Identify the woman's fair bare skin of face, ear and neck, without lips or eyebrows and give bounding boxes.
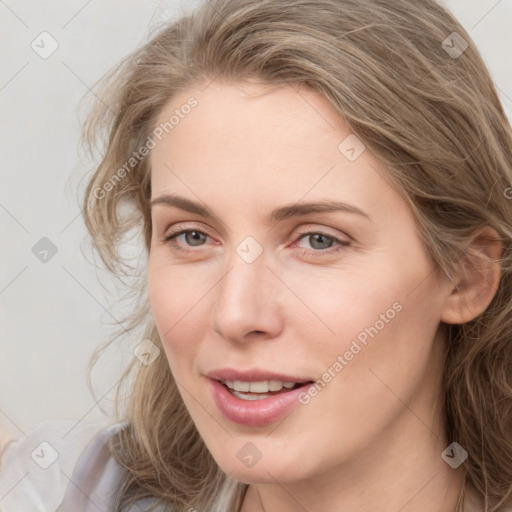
[147,81,499,512]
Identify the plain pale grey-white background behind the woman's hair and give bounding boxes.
[0,0,512,444]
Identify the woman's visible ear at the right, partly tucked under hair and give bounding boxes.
[441,226,502,324]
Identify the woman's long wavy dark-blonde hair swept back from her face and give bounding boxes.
[83,0,512,512]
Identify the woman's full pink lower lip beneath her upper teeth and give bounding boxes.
[209,379,313,427]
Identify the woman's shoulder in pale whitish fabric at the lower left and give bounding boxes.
[0,419,124,512]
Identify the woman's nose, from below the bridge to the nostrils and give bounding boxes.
[211,252,283,343]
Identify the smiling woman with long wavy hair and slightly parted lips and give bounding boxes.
[1,0,512,512]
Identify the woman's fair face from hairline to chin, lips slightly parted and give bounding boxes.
[148,82,448,482]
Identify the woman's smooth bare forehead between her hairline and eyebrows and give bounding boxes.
[146,82,402,221]
